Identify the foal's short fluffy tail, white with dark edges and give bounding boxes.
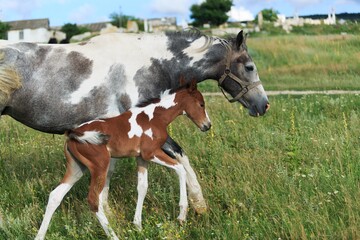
[66,130,110,145]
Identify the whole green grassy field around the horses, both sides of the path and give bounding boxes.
[0,36,360,240]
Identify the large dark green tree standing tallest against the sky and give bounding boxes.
[190,0,233,27]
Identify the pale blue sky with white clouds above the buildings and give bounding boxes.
[0,0,360,26]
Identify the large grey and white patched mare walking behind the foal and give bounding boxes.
[0,29,270,218]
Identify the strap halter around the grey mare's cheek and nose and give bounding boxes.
[218,58,261,103]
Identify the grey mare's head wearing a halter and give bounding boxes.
[219,31,270,116]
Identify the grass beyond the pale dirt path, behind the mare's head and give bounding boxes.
[198,35,360,91]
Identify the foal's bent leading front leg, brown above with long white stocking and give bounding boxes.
[151,150,188,223]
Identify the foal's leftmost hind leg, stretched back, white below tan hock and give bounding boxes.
[35,144,86,240]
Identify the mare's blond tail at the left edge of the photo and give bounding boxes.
[0,51,21,108]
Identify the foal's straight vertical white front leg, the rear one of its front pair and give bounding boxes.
[134,157,149,230]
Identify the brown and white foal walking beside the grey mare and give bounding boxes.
[36,82,211,239]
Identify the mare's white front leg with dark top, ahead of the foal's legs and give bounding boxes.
[162,137,207,214]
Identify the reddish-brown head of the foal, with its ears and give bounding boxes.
[176,81,211,132]
